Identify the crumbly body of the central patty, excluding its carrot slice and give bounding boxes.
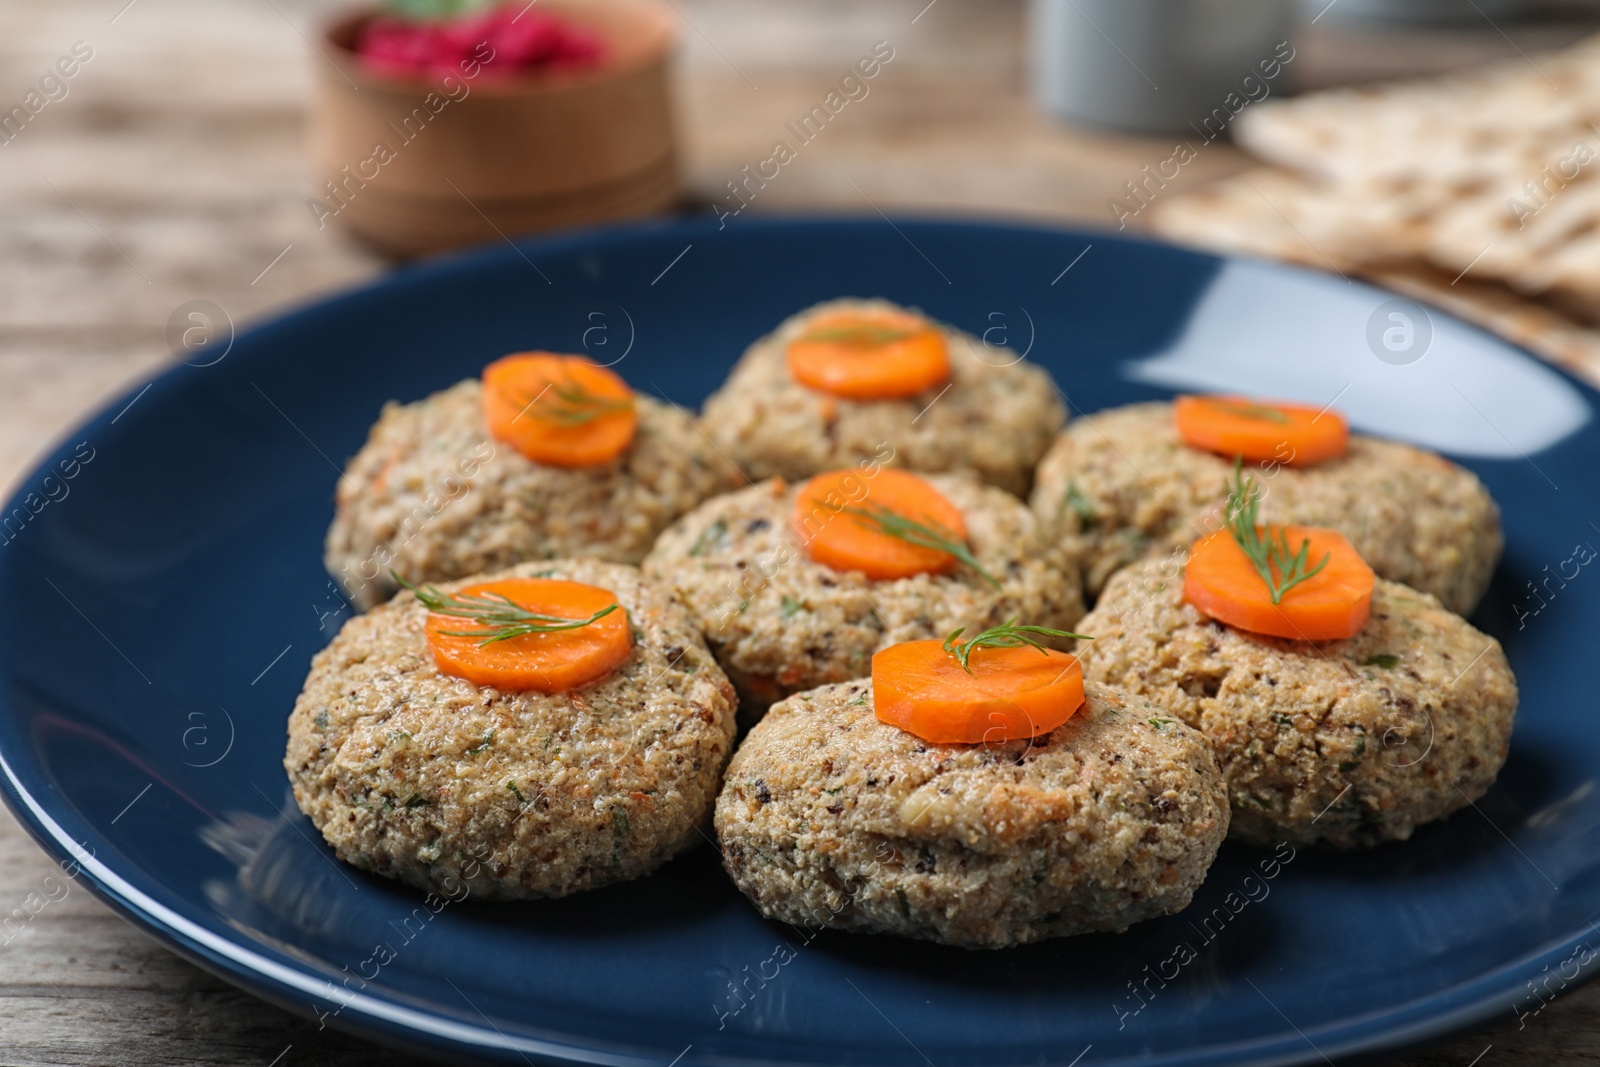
[643,467,1083,717]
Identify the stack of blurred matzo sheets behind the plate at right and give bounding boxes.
[1154,37,1600,381]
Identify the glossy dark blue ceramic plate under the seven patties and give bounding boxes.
[0,219,1600,1067]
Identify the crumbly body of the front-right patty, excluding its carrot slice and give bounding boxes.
[1078,560,1517,848]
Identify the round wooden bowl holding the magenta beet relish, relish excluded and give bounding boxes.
[309,0,680,256]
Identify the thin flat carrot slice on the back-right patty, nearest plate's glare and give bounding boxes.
[1173,397,1350,467]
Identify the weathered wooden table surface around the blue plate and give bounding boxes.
[0,0,1600,1067]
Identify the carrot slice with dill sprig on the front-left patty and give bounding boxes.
[418,577,634,693]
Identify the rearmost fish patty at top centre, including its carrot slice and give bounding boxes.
[702,299,1067,494]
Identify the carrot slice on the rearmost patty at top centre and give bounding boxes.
[787,310,950,400]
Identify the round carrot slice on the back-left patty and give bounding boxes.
[483,352,638,467]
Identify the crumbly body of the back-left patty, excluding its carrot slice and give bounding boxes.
[326,379,744,608]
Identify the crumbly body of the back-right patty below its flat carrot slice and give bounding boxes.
[1032,403,1502,614]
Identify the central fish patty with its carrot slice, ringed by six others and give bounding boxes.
[643,464,1083,720]
